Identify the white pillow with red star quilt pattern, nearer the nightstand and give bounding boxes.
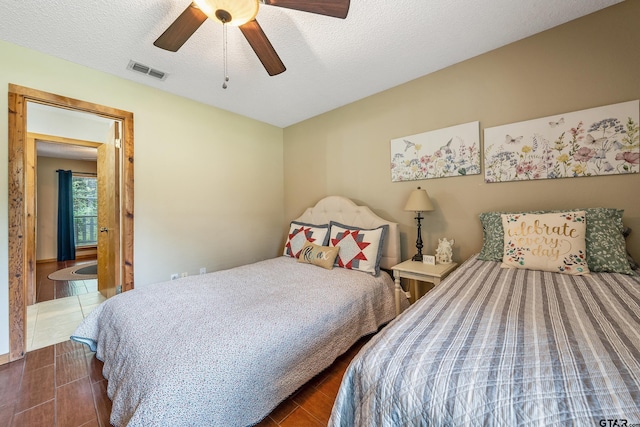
[329,221,389,276]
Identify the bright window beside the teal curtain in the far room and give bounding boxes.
[73,174,98,247]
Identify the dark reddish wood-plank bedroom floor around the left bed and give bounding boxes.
[0,337,370,427]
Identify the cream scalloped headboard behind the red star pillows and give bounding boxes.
[296,196,401,269]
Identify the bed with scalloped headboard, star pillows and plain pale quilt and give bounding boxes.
[72,196,408,426]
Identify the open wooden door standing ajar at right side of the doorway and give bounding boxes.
[97,122,121,298]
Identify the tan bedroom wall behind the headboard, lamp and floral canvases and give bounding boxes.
[284,1,640,260]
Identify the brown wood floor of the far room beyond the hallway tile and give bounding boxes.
[36,258,98,302]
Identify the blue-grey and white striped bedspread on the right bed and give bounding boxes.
[329,257,640,426]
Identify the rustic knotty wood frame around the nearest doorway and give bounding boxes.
[8,83,133,361]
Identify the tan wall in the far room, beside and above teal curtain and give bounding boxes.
[36,157,97,260]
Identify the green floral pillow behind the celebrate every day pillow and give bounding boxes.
[478,208,635,275]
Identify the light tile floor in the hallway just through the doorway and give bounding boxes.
[27,292,105,352]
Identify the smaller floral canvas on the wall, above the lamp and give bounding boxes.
[391,122,480,182]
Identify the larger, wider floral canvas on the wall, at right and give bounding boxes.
[484,100,640,182]
